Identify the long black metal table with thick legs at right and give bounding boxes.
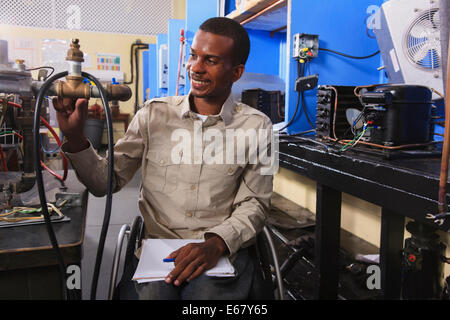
[279,138,450,299]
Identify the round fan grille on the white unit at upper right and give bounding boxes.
[403,8,441,71]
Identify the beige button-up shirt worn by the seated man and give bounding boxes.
[63,95,273,255]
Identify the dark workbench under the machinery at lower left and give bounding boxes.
[0,171,88,299]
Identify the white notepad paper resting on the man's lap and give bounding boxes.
[133,239,234,283]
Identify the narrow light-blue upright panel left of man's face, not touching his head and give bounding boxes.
[167,19,186,96]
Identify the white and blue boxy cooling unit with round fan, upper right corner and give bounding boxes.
[374,0,444,99]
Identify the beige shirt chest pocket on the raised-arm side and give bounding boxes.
[145,149,180,193]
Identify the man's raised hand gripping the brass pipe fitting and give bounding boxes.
[52,97,89,153]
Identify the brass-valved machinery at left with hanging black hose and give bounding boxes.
[0,39,131,298]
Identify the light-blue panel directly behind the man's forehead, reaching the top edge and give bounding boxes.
[184,0,218,93]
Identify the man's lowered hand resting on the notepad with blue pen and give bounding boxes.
[165,234,228,286]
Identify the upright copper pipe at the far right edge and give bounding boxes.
[438,33,450,213]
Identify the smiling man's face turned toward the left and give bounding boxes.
[186,30,244,99]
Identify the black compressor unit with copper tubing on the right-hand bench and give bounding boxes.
[316,84,438,157]
